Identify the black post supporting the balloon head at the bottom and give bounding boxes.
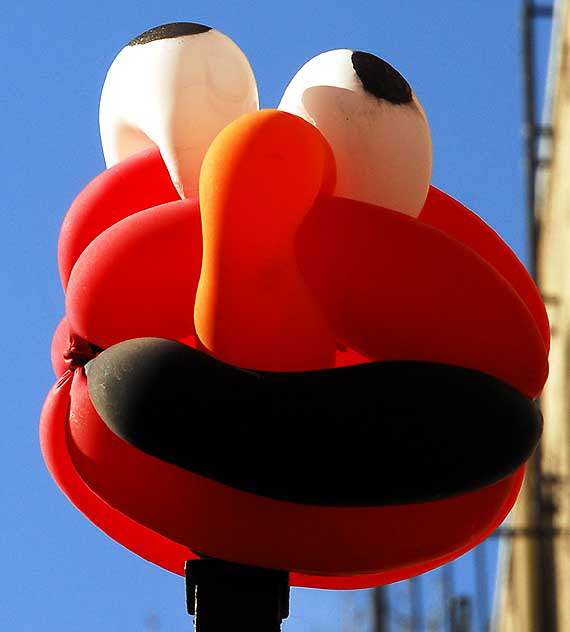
[186,558,289,632]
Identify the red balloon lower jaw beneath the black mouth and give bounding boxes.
[40,370,522,589]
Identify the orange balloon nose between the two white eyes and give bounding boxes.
[194,110,335,371]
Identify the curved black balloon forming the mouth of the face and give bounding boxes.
[85,338,542,507]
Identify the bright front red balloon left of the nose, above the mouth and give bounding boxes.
[66,200,202,348]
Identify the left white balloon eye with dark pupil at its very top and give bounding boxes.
[99,22,258,197]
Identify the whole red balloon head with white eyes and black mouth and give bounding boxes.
[41,23,549,628]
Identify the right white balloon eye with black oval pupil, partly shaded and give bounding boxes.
[279,49,432,217]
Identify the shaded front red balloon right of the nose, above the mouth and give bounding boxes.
[297,197,548,397]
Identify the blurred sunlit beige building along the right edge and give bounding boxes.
[494,0,570,632]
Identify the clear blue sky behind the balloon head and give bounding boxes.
[0,0,544,632]
